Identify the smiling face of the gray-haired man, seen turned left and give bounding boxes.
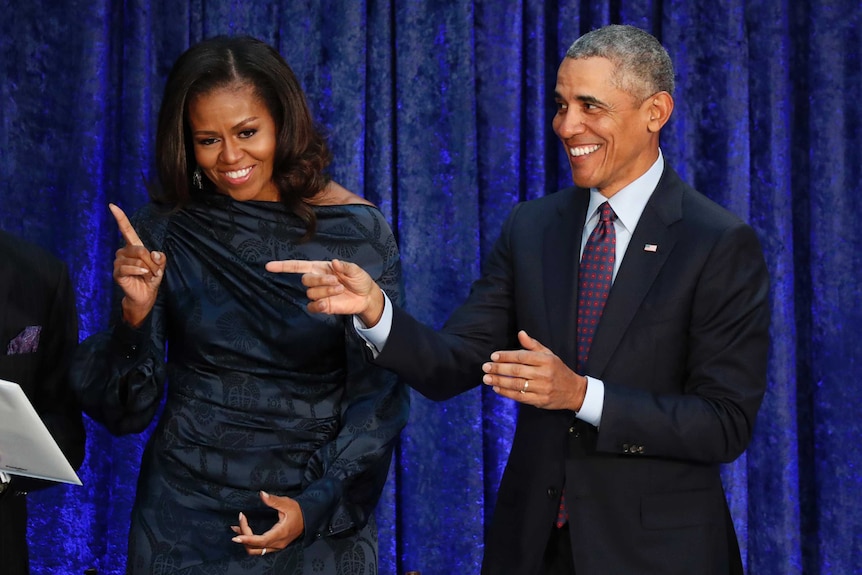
[553,58,658,198]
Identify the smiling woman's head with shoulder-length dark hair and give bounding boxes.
[152,36,342,240]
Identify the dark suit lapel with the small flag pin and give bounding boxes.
[587,167,683,378]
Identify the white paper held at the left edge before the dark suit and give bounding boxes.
[0,379,81,485]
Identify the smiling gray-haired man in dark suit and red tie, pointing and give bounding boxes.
[268,26,769,575]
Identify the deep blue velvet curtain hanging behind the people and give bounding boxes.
[0,0,862,575]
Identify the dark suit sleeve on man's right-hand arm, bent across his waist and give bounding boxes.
[597,223,769,463]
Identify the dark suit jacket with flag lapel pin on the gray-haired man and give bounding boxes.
[376,167,769,575]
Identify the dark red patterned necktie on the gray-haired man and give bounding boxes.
[557,202,617,527]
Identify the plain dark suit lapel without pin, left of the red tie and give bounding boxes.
[542,190,590,368]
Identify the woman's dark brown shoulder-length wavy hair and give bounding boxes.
[151,36,331,238]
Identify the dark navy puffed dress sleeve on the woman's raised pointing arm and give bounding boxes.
[71,208,166,435]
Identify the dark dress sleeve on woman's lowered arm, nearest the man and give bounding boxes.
[296,212,410,545]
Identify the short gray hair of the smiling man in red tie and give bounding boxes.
[566,24,674,102]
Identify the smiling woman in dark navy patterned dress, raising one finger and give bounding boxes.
[73,37,409,575]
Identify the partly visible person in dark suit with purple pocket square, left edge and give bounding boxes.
[0,231,84,575]
